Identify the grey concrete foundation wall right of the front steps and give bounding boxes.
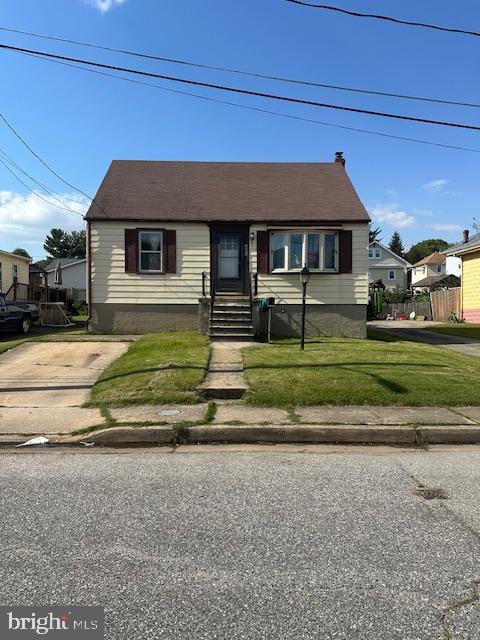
[254,304,367,338]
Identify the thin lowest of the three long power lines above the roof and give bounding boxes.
[25,49,480,153]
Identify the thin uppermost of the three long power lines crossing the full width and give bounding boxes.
[0,27,480,109]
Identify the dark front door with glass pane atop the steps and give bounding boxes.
[214,231,248,293]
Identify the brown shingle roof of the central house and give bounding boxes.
[87,160,369,222]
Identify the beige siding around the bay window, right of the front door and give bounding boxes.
[250,224,368,304]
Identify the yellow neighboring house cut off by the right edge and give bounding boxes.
[445,230,480,322]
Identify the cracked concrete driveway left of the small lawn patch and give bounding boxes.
[0,341,130,435]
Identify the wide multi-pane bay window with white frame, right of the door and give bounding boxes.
[270,231,338,271]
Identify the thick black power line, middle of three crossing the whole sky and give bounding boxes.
[0,44,480,131]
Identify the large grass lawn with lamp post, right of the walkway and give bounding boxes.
[243,332,480,407]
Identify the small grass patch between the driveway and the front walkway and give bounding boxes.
[88,331,210,407]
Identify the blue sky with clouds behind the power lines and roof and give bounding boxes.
[0,0,480,258]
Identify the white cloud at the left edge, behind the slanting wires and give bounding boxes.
[0,191,88,254]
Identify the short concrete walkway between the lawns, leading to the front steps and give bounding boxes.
[199,340,252,400]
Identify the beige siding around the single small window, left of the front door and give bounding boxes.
[91,222,210,304]
